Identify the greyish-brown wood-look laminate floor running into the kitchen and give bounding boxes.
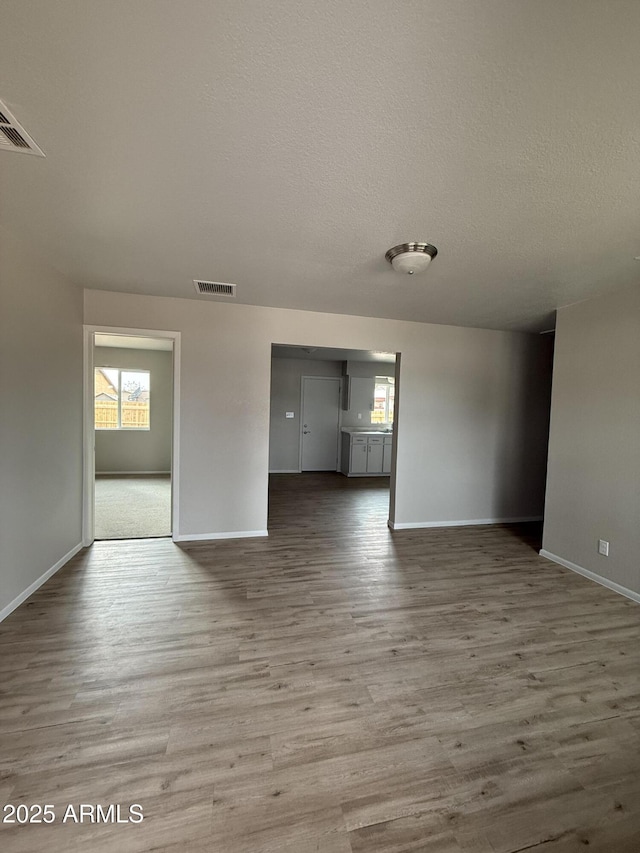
[0,474,640,853]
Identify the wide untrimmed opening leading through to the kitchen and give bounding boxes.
[269,344,399,530]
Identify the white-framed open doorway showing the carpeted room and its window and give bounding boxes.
[84,327,178,545]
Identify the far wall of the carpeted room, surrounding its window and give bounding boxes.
[94,347,173,474]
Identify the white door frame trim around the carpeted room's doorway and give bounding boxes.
[82,324,180,548]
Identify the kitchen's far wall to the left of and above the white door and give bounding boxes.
[269,358,342,472]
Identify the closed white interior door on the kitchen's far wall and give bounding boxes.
[300,376,340,471]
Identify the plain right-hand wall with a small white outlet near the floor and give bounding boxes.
[543,286,640,595]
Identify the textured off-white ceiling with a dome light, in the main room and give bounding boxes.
[0,0,640,331]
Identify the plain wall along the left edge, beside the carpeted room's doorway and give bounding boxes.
[0,228,82,618]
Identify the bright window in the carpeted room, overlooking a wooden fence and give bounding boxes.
[95,367,151,429]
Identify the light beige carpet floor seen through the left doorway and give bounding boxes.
[95,475,171,539]
